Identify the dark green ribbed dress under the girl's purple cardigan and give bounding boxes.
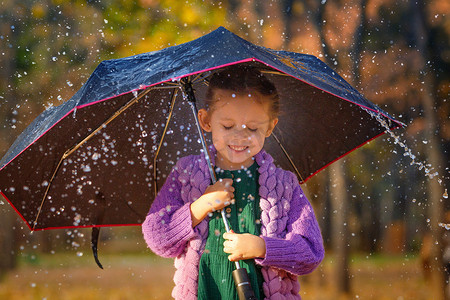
[198,163,264,300]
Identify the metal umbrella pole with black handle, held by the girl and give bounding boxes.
[181,80,256,300]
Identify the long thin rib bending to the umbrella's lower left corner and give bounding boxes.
[33,87,154,230]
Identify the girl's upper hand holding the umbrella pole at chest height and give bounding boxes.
[190,178,234,227]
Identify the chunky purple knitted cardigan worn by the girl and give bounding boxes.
[142,148,324,300]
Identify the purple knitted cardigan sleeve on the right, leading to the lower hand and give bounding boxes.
[255,175,325,275]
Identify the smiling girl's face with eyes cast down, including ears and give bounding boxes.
[198,89,278,170]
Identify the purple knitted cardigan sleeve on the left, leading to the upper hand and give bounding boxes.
[142,161,196,257]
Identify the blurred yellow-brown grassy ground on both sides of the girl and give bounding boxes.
[0,251,432,300]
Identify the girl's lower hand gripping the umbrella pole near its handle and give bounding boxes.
[223,232,266,261]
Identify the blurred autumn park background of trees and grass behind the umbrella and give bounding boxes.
[0,0,450,299]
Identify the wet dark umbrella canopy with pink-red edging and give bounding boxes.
[0,27,402,230]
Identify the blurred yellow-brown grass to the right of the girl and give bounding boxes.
[300,255,435,300]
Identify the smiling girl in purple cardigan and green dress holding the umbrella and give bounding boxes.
[142,65,324,299]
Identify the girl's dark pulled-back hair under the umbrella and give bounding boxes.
[205,64,280,119]
